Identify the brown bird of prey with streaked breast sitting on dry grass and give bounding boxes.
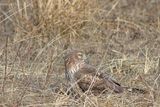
[64,50,124,93]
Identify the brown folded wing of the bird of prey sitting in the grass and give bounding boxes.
[75,64,123,93]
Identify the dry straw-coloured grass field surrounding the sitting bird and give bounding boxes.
[0,0,160,107]
